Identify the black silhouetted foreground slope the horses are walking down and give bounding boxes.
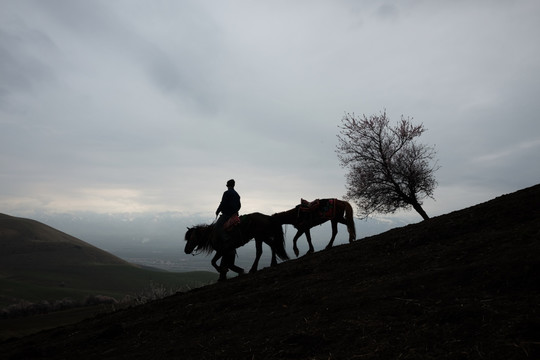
[0,185,540,360]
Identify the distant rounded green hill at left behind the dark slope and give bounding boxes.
[0,214,217,306]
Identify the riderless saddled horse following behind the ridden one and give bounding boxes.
[272,199,356,257]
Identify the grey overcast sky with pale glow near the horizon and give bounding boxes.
[0,0,540,221]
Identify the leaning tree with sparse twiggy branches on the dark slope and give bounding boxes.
[336,111,439,220]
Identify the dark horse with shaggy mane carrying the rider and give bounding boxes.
[184,212,289,280]
